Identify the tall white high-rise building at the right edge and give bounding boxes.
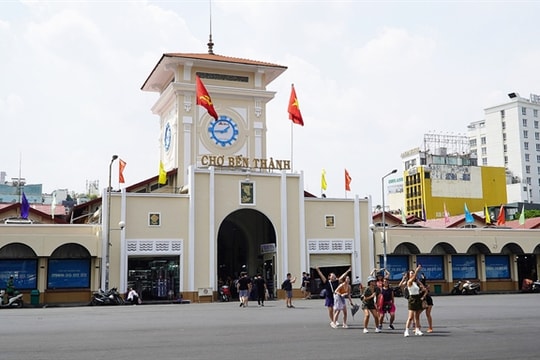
[468,93,540,203]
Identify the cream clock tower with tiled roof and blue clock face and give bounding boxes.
[142,51,287,187]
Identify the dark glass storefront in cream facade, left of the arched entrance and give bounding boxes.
[128,256,180,300]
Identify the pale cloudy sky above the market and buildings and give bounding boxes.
[0,0,540,205]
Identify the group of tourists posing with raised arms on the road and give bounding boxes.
[316,265,433,337]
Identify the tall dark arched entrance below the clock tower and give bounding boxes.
[217,209,276,296]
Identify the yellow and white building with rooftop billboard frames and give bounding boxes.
[401,134,506,219]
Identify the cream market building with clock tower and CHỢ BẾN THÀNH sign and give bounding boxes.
[0,48,540,303]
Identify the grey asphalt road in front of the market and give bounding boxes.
[0,294,540,360]
